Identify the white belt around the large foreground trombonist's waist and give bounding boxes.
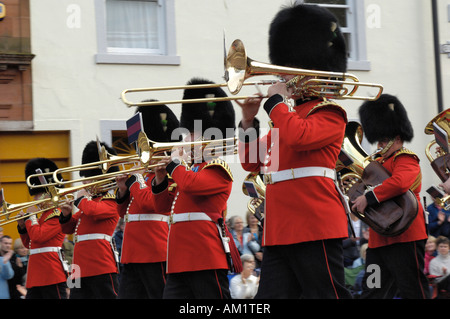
[264,166,336,184]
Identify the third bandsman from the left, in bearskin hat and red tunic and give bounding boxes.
[116,105,179,299]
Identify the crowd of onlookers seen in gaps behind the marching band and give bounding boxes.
[0,203,450,299]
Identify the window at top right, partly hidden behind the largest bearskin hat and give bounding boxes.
[297,0,370,70]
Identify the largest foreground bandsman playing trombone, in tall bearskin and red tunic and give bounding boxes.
[239,5,351,299]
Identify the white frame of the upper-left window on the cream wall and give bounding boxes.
[94,0,180,65]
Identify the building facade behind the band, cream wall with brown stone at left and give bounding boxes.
[0,0,450,235]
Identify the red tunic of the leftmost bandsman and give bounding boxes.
[20,209,67,288]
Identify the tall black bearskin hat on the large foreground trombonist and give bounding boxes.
[269,4,347,72]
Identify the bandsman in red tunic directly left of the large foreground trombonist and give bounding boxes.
[153,79,240,299]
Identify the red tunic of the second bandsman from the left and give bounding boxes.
[61,197,119,278]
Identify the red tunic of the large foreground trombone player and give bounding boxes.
[239,99,348,246]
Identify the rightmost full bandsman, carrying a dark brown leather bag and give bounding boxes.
[352,94,430,299]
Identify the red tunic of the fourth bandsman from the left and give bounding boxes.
[165,163,233,274]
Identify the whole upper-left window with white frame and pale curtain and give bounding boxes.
[95,0,180,65]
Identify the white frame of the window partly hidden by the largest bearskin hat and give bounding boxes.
[296,0,371,71]
